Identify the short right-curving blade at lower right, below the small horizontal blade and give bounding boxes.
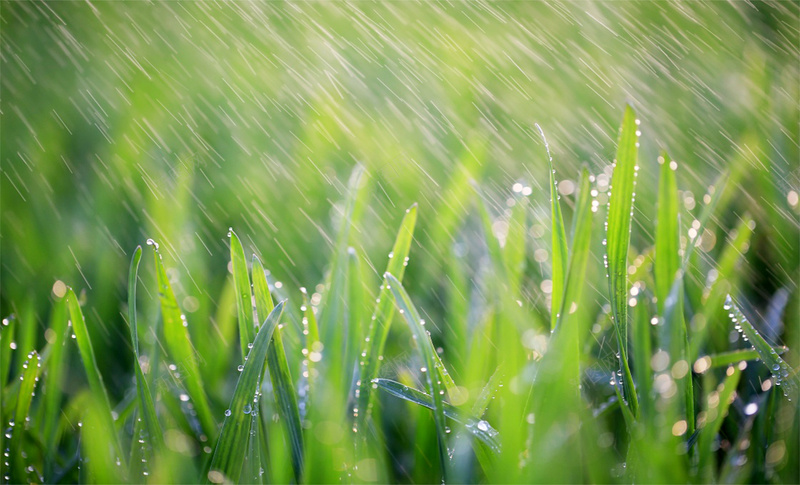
[697,365,742,483]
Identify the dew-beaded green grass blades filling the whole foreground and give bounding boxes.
[2,107,798,483]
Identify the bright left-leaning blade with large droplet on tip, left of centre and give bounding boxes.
[147,239,217,441]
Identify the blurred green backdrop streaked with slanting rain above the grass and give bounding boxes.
[0,2,800,402]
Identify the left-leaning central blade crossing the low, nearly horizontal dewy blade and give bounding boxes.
[384,273,449,482]
